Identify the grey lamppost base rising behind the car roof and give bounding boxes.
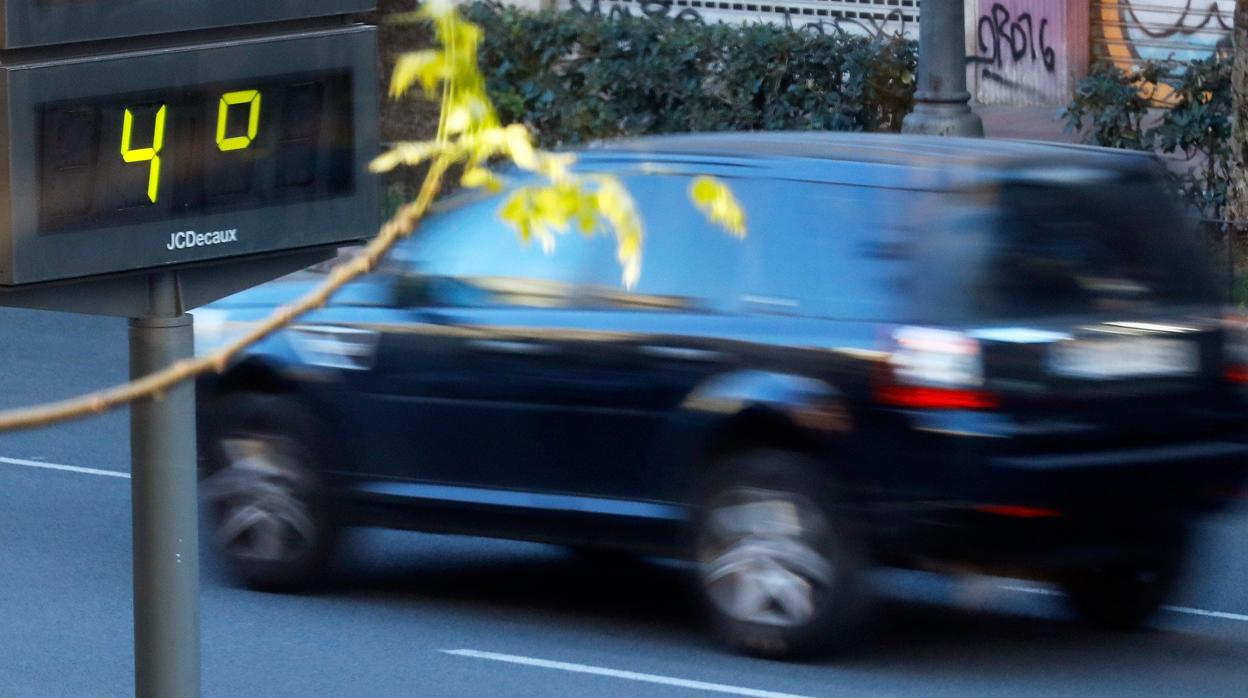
[901,0,983,137]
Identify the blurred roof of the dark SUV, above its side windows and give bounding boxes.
[578,131,1157,189]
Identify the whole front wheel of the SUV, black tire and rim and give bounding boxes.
[200,393,339,592]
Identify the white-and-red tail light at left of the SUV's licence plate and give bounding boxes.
[875,327,1000,410]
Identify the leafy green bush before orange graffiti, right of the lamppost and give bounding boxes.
[1065,54,1232,219]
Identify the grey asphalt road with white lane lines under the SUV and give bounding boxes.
[0,311,1248,698]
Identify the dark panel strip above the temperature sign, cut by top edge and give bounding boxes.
[0,0,377,49]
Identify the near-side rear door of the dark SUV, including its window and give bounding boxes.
[526,172,745,501]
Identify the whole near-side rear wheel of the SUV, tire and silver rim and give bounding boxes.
[694,450,865,659]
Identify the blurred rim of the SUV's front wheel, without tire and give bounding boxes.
[203,435,317,562]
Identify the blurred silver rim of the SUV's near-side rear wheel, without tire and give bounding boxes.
[699,488,836,627]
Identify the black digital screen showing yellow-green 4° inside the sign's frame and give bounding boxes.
[39,71,356,233]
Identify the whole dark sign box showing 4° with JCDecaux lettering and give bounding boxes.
[0,25,381,286]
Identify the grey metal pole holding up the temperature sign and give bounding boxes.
[130,272,200,698]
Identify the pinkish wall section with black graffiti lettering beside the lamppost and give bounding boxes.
[967,0,1067,102]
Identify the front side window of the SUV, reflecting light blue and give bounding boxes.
[389,196,588,307]
